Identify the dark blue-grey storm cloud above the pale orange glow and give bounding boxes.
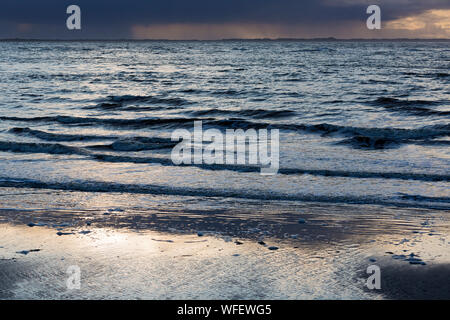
[0,0,450,37]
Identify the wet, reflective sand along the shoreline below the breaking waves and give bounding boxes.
[0,205,450,299]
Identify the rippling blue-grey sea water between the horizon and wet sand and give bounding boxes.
[0,41,450,214]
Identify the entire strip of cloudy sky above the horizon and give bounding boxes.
[0,0,450,40]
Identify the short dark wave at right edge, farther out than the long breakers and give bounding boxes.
[372,97,450,116]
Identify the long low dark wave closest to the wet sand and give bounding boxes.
[0,177,450,210]
